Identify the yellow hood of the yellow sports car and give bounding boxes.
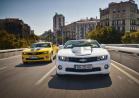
[23,47,51,52]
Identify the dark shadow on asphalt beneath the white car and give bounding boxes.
[48,75,112,90]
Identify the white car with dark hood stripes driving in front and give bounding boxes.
[56,40,110,76]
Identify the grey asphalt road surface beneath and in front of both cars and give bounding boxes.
[0,56,139,98]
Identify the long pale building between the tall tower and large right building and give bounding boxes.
[64,18,99,40]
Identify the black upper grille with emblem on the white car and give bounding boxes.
[69,57,97,63]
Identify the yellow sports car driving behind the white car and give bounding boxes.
[22,42,58,63]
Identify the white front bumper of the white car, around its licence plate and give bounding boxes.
[56,60,110,75]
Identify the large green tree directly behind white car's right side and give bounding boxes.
[87,27,121,44]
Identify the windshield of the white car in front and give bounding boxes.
[64,40,100,48]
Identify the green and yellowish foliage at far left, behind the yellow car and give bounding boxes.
[0,30,39,49]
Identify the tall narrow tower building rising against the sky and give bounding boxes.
[53,13,65,32]
